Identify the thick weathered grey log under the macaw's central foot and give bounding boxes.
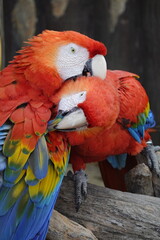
[50,177,160,240]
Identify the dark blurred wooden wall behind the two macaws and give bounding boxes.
[0,0,160,144]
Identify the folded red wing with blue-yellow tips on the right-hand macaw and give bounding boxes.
[113,71,155,143]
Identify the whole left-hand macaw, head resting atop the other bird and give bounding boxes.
[0,31,106,240]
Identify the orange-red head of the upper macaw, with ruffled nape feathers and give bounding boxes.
[12,30,106,95]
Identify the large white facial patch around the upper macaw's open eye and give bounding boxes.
[56,43,89,80]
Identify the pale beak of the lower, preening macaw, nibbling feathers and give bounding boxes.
[48,107,88,131]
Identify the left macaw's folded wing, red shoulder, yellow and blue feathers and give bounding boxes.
[0,101,69,240]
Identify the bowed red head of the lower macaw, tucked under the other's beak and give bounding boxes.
[48,71,120,137]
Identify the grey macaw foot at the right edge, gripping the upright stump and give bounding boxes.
[142,141,160,177]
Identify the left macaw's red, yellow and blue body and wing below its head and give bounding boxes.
[0,57,69,240]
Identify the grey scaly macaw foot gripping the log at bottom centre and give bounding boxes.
[67,169,88,212]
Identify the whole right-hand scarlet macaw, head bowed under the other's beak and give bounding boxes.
[49,70,159,209]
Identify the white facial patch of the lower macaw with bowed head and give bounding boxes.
[58,91,87,111]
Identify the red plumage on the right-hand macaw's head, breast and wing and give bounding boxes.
[53,70,152,189]
